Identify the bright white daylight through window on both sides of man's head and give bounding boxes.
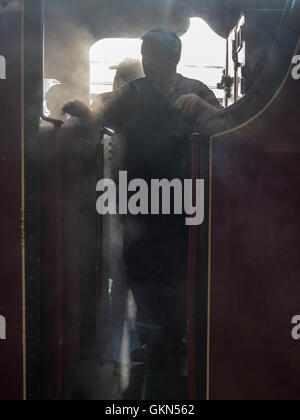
[90,18,226,101]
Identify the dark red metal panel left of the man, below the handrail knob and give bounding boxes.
[40,128,82,400]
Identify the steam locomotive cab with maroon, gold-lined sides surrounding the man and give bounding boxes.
[0,0,300,400]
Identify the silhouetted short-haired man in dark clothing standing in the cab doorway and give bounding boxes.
[64,28,221,361]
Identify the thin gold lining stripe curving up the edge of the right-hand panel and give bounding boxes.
[206,38,300,401]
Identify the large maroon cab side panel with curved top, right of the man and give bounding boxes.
[209,43,300,400]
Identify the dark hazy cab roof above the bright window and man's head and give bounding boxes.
[46,0,285,40]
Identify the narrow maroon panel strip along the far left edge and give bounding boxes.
[0,8,23,400]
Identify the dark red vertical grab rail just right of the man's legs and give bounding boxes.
[187,133,209,400]
